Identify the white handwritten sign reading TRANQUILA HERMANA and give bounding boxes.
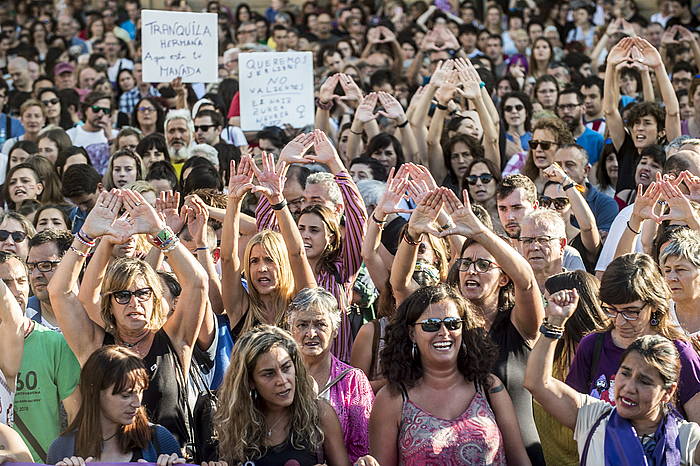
[141,10,219,83]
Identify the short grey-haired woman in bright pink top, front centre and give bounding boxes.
[287,287,374,462]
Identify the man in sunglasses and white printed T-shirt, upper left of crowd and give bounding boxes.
[66,92,118,174]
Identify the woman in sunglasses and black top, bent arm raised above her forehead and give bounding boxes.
[539,163,602,273]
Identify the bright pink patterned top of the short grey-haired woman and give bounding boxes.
[319,354,374,463]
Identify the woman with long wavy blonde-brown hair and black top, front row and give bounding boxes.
[214,325,350,466]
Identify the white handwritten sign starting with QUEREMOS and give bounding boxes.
[238,52,314,131]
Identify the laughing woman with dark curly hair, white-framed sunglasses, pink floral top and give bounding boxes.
[370,284,528,466]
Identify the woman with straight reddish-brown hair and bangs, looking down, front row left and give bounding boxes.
[47,345,184,466]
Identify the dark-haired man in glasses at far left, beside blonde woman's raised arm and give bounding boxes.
[25,229,73,332]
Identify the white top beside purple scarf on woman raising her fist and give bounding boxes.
[574,393,700,466]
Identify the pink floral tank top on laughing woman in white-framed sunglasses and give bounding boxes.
[399,384,506,466]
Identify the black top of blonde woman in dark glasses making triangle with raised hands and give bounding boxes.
[103,329,187,446]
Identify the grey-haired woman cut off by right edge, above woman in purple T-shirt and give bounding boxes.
[659,228,700,340]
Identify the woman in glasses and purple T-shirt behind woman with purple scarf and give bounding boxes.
[566,254,700,422]
